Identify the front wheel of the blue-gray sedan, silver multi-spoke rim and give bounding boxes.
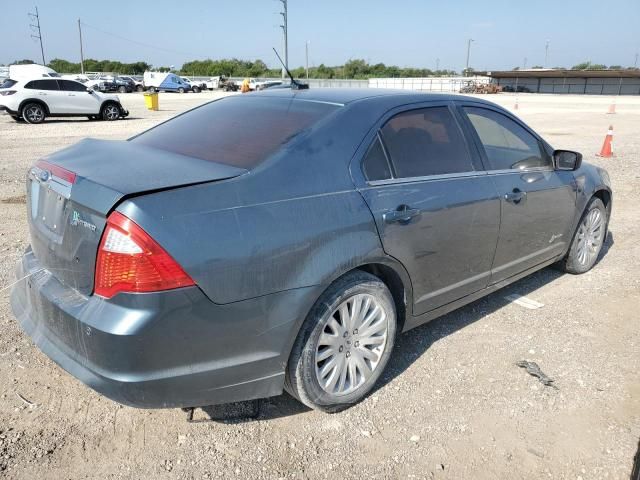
[558,197,609,275]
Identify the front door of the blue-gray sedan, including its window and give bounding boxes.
[462,103,576,283]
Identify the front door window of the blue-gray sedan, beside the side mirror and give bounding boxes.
[464,107,551,170]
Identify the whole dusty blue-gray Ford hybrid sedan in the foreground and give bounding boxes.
[11,89,612,412]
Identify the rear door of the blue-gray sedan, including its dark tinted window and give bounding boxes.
[352,102,500,315]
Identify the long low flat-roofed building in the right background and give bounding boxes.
[476,68,640,95]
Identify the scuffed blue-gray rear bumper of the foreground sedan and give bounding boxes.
[11,249,316,408]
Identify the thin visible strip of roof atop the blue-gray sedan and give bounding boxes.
[251,88,490,105]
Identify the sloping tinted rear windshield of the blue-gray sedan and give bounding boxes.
[131,94,339,169]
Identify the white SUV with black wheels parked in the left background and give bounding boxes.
[0,78,129,123]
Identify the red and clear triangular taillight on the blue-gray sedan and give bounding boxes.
[95,212,194,298]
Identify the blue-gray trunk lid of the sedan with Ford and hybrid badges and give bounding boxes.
[27,139,247,295]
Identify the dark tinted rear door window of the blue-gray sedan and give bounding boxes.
[381,107,474,178]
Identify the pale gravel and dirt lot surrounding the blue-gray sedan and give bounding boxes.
[0,93,640,480]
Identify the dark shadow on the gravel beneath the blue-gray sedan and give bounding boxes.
[192,232,616,424]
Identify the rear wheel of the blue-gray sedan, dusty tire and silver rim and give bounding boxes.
[285,271,397,413]
